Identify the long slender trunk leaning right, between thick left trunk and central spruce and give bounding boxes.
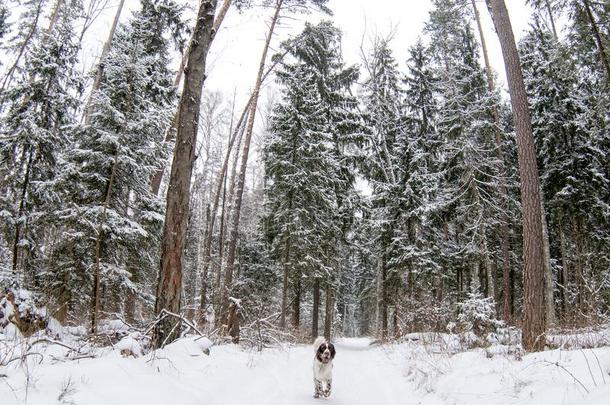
[221,0,284,322]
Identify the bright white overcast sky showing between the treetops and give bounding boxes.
[84,0,531,106]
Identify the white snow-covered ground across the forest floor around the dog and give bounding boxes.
[0,335,610,405]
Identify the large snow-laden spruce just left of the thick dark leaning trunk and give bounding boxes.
[54,0,182,330]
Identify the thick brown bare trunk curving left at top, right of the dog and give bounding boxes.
[487,0,546,351]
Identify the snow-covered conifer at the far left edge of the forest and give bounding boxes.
[0,2,81,282]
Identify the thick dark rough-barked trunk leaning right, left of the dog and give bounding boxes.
[153,0,218,348]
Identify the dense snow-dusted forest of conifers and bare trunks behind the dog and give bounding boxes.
[0,0,610,403]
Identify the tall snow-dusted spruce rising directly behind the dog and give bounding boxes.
[265,22,357,332]
